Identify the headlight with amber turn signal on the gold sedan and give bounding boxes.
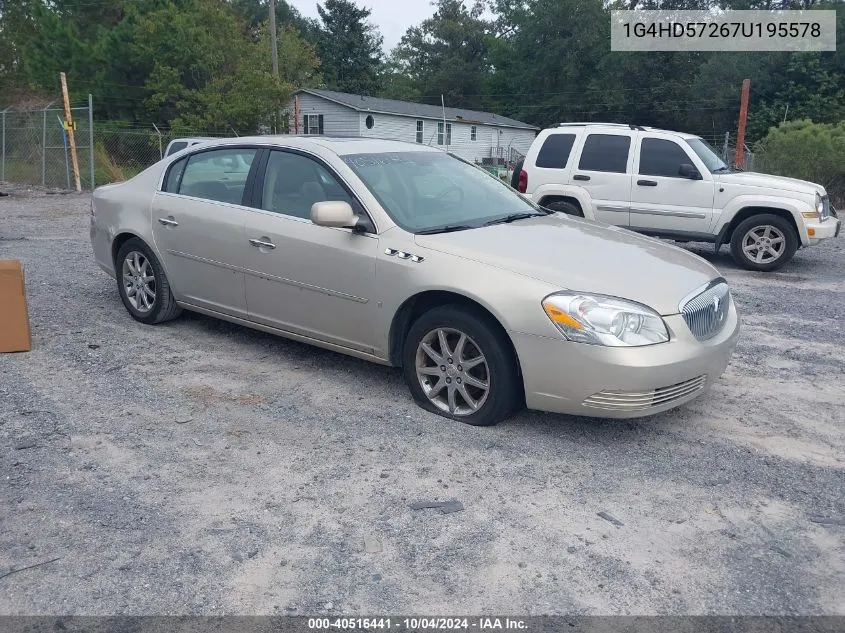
[543,292,669,347]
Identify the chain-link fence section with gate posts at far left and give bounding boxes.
[0,101,94,189]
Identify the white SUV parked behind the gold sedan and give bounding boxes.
[514,123,840,271]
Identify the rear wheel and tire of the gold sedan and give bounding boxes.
[114,237,182,325]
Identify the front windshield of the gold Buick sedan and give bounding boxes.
[342,151,543,233]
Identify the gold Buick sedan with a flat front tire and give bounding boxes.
[91,136,739,425]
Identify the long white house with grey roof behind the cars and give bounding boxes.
[288,88,539,164]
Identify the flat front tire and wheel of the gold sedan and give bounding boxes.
[402,305,522,426]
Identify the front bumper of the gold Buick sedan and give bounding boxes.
[511,305,740,418]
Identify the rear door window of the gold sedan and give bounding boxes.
[176,147,258,204]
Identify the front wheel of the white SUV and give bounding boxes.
[731,213,798,272]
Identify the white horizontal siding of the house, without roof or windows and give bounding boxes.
[290,93,536,163]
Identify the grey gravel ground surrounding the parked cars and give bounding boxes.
[0,188,845,615]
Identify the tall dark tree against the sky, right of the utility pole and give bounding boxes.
[317,0,382,95]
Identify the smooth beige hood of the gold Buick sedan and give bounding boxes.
[415,214,719,315]
